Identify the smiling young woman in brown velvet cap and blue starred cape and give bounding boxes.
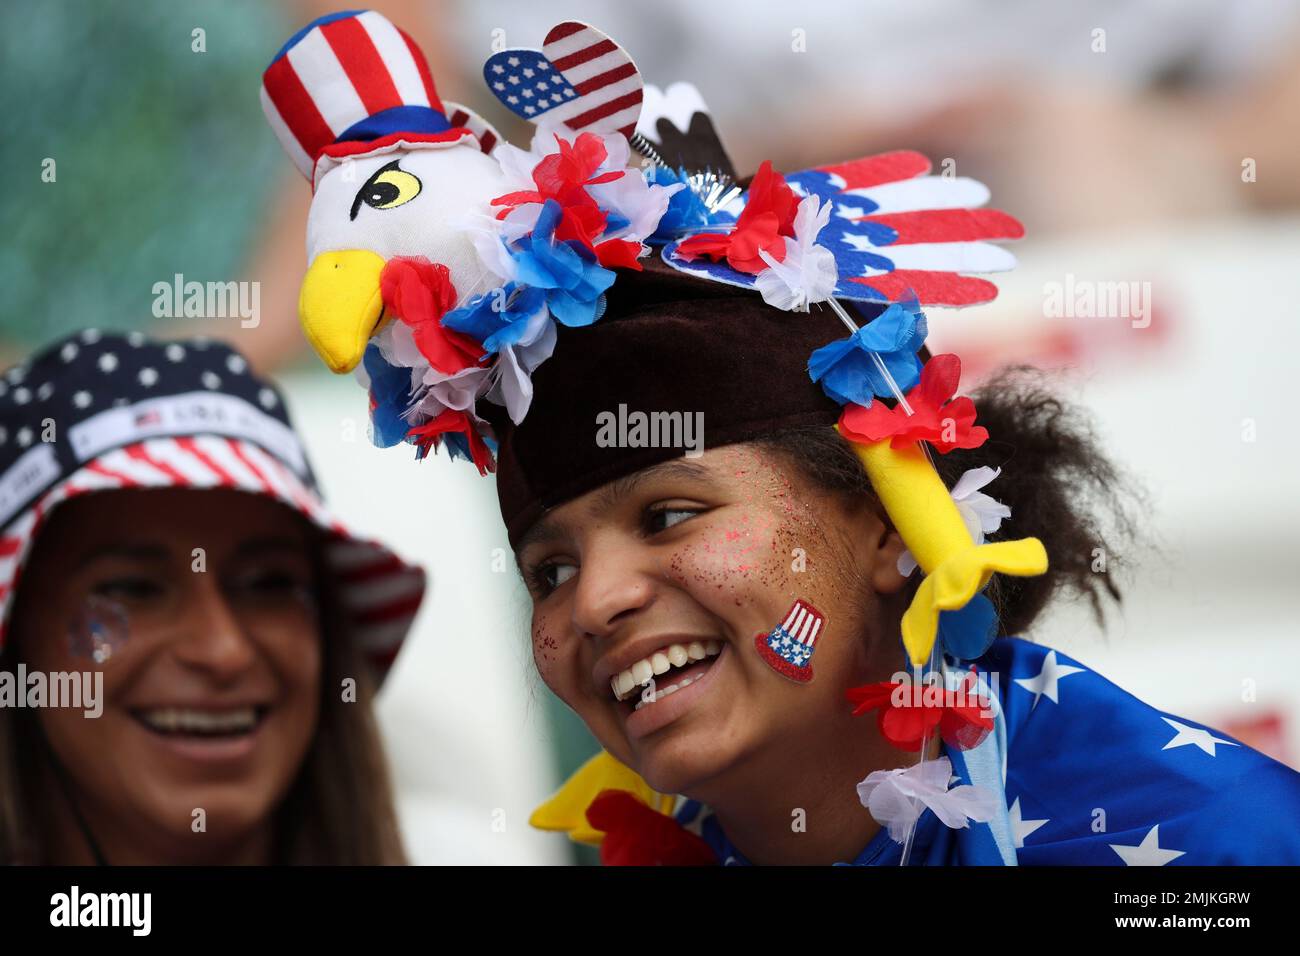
[481,264,1300,865]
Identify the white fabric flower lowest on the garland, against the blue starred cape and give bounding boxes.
[858,757,998,843]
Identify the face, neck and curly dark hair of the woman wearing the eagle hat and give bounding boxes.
[517,361,1127,864]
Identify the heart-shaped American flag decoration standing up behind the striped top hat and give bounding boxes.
[484,21,642,139]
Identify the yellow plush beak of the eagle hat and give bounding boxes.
[298,248,385,375]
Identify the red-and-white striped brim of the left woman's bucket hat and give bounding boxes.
[0,434,425,675]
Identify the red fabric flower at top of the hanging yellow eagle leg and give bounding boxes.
[840,355,988,453]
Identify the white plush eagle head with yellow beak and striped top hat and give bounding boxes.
[261,10,504,372]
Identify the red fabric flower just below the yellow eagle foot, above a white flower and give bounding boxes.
[848,667,993,753]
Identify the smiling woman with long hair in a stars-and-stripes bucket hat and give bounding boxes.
[0,333,424,865]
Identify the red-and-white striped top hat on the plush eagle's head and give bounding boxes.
[261,10,498,187]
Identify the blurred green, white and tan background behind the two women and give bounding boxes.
[0,0,1300,864]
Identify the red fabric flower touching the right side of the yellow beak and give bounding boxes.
[380,256,484,375]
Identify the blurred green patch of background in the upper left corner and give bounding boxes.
[0,0,290,351]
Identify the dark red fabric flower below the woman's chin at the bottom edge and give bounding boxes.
[586,790,718,866]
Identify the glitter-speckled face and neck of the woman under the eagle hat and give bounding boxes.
[519,444,920,862]
